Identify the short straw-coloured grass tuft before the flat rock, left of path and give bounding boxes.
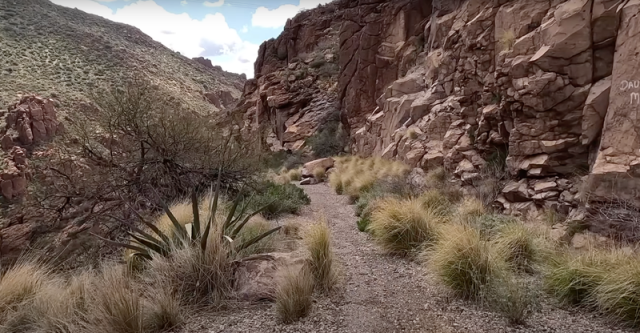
[275,266,314,324]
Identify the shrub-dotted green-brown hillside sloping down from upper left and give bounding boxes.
[0,0,245,111]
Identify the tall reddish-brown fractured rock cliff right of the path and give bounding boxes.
[241,0,640,218]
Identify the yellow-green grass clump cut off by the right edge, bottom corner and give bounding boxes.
[593,258,640,326]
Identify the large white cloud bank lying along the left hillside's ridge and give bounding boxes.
[51,0,259,77]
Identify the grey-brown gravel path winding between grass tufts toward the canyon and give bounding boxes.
[185,184,634,333]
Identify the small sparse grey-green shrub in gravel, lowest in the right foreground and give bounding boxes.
[483,274,540,325]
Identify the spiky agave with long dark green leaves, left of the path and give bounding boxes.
[102,175,281,260]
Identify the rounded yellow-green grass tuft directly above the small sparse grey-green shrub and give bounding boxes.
[495,223,542,272]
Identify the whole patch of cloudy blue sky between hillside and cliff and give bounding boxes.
[50,0,331,78]
